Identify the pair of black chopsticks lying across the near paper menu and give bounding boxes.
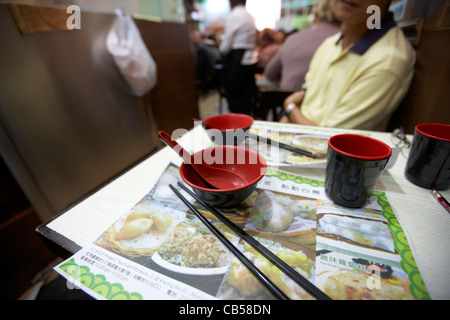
[170,182,331,300]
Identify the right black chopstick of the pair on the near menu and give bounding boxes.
[178,182,331,300]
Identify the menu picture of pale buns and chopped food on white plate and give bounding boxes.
[96,165,238,294]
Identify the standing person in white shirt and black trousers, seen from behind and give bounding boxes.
[219,0,258,114]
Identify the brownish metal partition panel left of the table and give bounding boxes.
[0,5,159,220]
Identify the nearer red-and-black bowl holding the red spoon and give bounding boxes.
[180,145,267,207]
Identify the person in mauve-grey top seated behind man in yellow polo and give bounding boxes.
[264,0,340,91]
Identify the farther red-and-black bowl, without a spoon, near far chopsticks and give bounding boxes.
[202,113,254,145]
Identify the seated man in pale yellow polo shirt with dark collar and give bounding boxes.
[280,0,415,131]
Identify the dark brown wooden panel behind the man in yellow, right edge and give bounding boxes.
[389,0,450,134]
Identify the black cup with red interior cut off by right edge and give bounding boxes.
[405,123,450,190]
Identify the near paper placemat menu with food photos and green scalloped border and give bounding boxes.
[55,163,430,300]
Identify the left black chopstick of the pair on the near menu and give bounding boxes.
[169,184,289,300]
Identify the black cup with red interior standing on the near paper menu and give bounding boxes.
[325,134,392,208]
